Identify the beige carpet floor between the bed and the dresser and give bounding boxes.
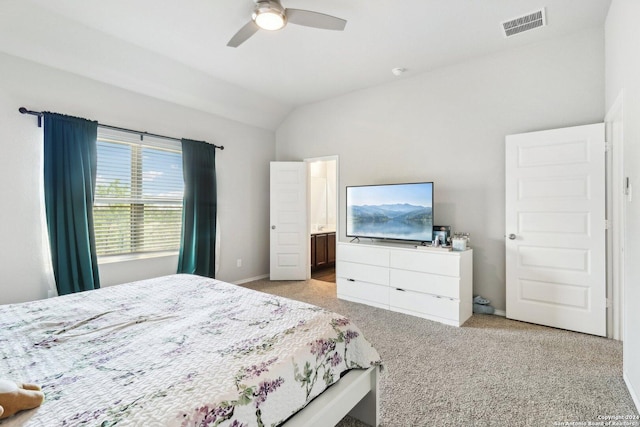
[243,280,640,427]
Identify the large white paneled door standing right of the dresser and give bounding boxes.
[505,123,607,336]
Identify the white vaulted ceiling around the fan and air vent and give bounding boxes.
[0,0,610,129]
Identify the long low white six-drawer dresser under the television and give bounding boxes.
[336,242,473,326]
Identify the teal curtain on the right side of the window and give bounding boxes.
[178,139,217,277]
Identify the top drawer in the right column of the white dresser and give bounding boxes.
[390,249,460,277]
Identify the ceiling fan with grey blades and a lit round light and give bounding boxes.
[227,0,347,47]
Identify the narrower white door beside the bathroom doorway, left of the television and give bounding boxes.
[269,162,310,280]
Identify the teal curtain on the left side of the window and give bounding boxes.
[43,113,100,295]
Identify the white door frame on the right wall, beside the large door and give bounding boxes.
[604,90,626,341]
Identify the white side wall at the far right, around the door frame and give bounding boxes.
[605,0,640,410]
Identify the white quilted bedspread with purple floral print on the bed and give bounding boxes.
[0,275,380,427]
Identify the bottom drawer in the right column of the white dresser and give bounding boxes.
[389,288,460,322]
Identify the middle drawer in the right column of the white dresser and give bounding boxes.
[389,268,460,299]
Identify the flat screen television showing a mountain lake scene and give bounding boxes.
[346,182,433,242]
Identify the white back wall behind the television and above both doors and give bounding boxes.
[276,29,604,310]
